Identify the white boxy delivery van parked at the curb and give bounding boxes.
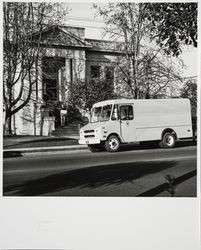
[79,99,192,152]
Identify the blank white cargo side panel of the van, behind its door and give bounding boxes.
[134,99,192,141]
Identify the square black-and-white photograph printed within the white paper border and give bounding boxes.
[3,1,199,198]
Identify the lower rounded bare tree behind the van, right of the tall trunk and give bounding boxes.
[139,48,183,99]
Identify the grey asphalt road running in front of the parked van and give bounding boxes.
[3,144,197,197]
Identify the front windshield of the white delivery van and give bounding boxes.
[91,105,112,122]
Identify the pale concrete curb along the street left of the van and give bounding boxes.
[3,145,88,158]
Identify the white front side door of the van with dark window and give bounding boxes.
[119,104,137,142]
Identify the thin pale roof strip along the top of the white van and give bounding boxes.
[93,98,189,107]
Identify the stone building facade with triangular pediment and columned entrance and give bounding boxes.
[13,26,120,135]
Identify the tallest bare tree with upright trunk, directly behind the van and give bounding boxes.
[94,3,147,98]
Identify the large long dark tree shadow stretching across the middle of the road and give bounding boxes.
[3,161,176,196]
